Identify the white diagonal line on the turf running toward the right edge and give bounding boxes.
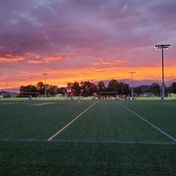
[118,103,176,142]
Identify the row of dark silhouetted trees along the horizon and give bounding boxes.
[20,79,176,96]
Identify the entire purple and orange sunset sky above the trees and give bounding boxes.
[0,0,176,90]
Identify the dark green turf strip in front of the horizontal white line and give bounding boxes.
[0,142,176,176]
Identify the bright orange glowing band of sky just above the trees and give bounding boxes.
[2,64,176,89]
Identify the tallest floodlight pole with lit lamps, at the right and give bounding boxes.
[155,44,170,100]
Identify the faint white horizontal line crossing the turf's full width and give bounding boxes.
[0,139,176,145]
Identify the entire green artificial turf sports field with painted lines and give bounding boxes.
[0,100,176,176]
